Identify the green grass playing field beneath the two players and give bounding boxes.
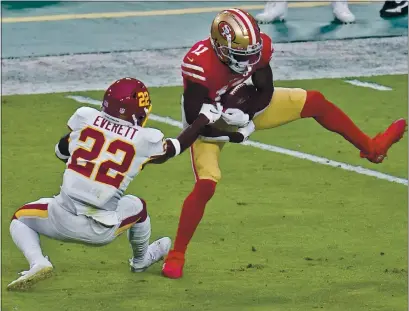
[2,75,408,311]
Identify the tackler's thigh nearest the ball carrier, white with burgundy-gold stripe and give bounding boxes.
[113,195,148,237]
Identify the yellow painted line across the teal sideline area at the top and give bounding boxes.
[1,1,360,23]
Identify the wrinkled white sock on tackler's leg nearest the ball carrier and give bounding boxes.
[128,215,151,264]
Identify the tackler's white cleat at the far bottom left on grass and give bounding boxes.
[7,257,53,290]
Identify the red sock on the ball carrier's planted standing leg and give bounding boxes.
[174,179,216,253]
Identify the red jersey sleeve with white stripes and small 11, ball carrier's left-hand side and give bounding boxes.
[181,41,211,87]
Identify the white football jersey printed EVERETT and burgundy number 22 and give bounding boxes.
[61,107,165,211]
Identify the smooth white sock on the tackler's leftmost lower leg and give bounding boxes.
[10,219,44,268]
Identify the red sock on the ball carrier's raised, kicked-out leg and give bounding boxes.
[301,91,373,154]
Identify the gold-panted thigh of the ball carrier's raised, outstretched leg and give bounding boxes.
[253,87,307,130]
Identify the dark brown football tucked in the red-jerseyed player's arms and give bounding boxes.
[221,83,257,113]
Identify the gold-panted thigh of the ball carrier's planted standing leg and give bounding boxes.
[190,139,224,182]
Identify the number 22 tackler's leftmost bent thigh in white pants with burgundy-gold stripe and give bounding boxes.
[12,198,64,240]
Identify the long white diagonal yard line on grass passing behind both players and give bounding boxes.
[67,96,408,186]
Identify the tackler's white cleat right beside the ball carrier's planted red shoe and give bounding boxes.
[129,237,172,272]
